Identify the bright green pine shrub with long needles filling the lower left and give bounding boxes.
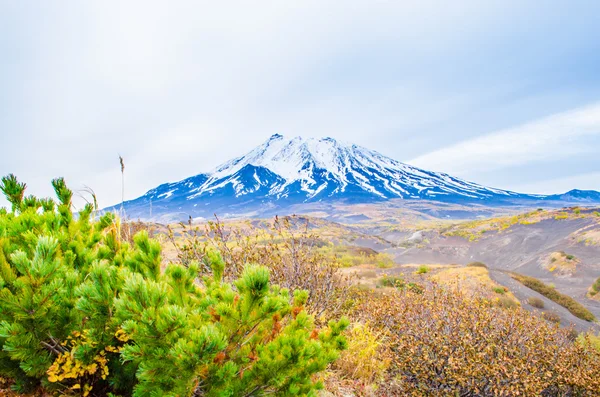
[0,175,348,396]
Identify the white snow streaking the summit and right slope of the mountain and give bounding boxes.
[197,134,518,200]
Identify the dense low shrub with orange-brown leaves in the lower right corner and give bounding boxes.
[356,287,600,397]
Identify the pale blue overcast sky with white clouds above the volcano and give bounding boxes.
[0,0,600,210]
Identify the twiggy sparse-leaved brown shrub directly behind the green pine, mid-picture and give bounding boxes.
[169,217,350,318]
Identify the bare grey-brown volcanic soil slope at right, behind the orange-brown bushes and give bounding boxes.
[386,218,600,330]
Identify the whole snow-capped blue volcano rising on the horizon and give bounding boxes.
[112,134,598,218]
